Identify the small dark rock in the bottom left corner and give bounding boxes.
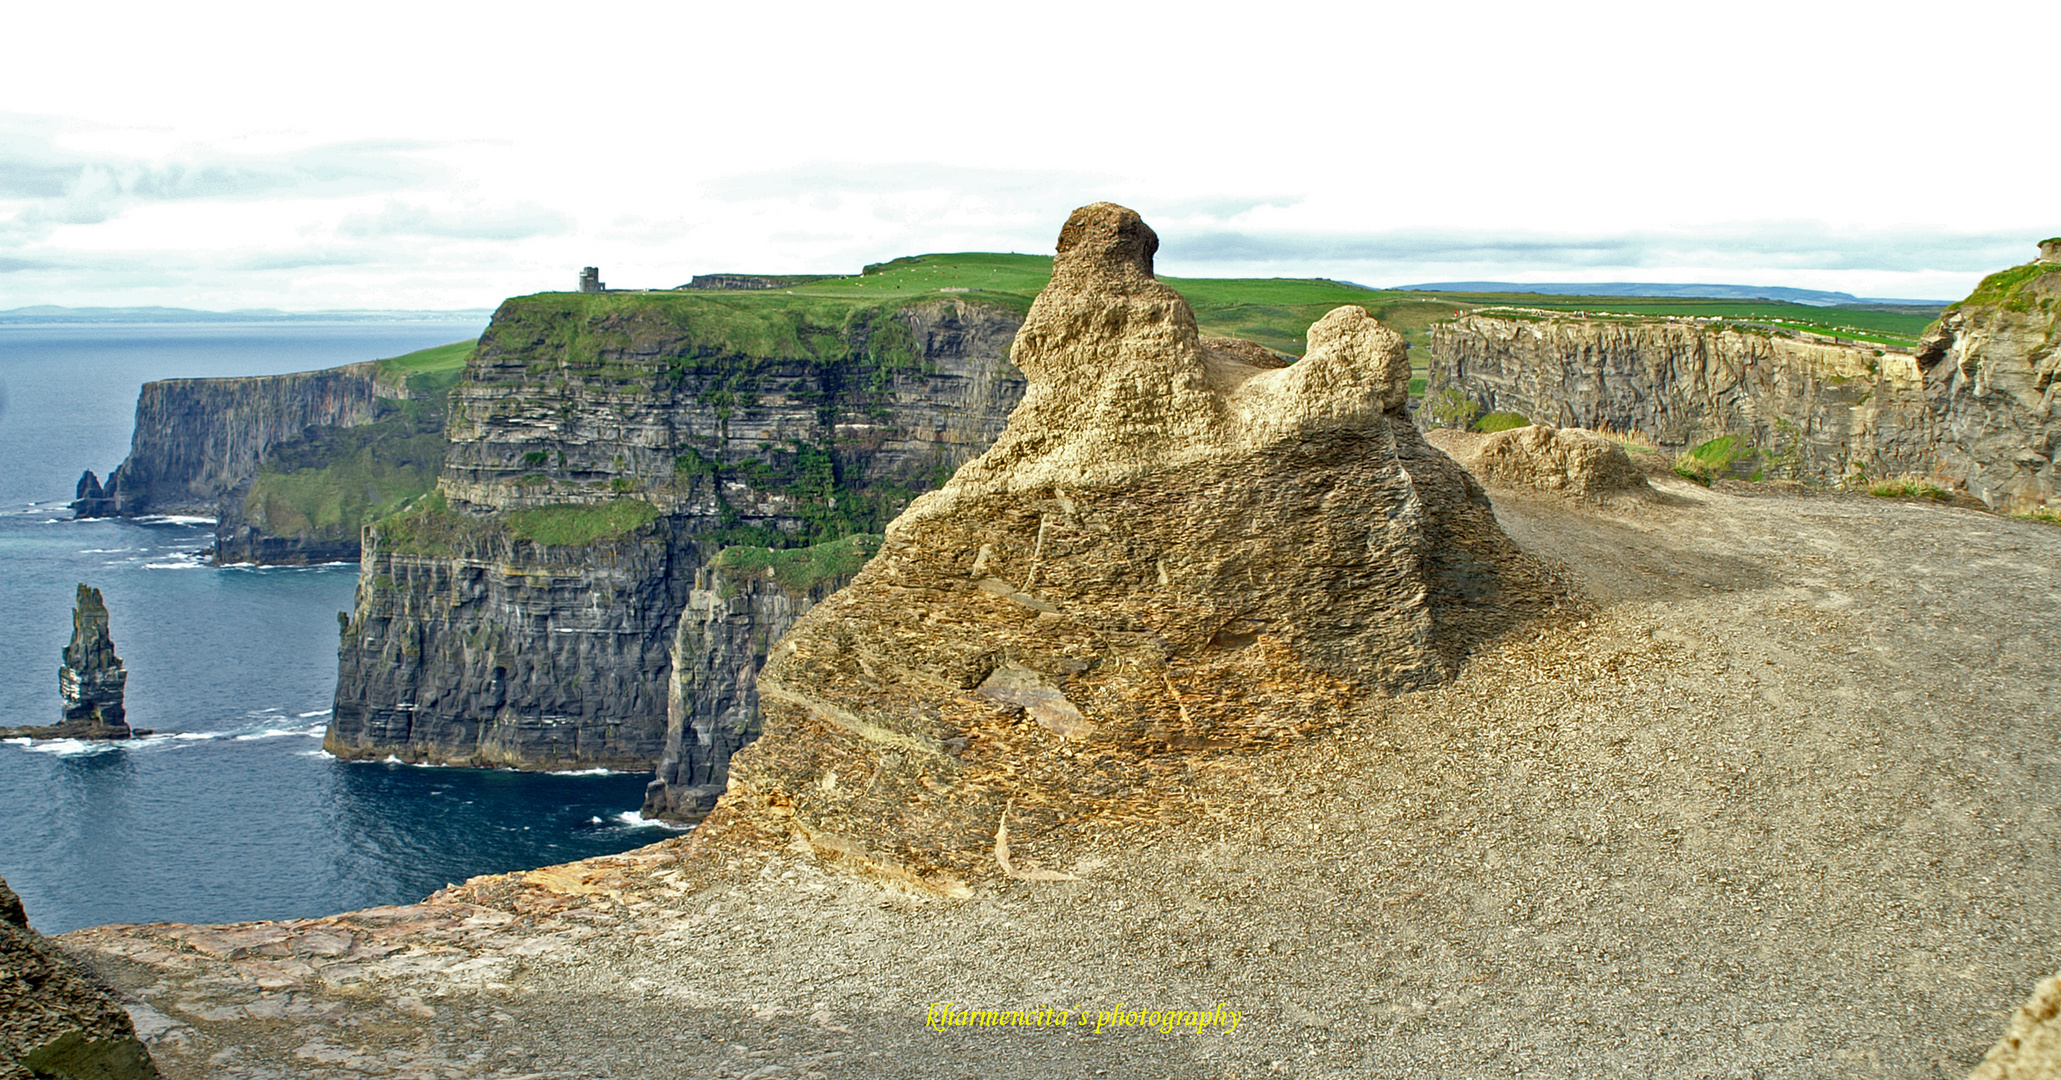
[0,882,157,1080]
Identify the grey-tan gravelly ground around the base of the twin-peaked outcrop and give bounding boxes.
[62,463,2061,1080]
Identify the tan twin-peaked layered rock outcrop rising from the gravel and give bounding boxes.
[703,204,1560,890]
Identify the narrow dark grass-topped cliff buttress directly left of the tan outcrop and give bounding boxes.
[643,536,878,820]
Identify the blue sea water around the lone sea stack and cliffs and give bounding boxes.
[0,324,684,934]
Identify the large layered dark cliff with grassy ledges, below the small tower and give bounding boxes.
[326,293,1022,766]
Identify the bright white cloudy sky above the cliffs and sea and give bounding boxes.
[0,0,2061,311]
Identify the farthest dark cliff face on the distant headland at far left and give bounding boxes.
[72,363,379,517]
